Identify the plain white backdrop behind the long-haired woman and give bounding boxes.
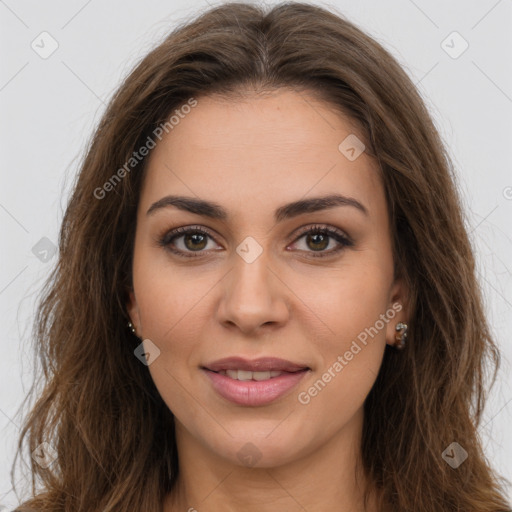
[0,0,512,510]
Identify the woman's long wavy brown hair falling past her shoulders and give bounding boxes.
[12,2,510,512]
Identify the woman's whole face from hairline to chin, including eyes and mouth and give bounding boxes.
[128,89,405,467]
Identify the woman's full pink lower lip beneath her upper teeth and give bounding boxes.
[203,369,309,406]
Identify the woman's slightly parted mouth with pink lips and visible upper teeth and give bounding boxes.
[200,357,311,407]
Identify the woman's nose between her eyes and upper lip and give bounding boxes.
[217,250,291,334]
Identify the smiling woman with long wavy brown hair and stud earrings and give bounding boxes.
[10,3,510,512]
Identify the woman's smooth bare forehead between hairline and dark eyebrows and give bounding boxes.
[141,89,384,220]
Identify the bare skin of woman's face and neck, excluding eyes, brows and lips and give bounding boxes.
[127,89,407,512]
